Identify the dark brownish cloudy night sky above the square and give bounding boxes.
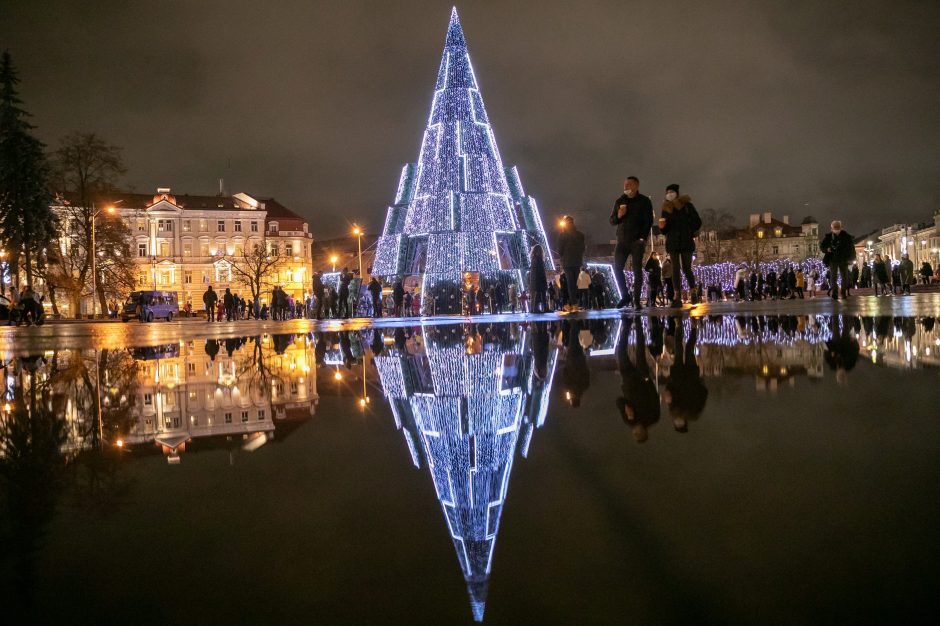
[0,0,940,239]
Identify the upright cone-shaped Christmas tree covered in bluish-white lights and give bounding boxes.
[372,8,554,313]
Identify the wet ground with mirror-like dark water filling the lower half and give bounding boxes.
[0,295,940,624]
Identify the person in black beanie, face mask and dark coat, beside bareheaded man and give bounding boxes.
[659,184,702,306]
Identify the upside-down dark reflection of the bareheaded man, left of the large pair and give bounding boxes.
[616,317,662,443]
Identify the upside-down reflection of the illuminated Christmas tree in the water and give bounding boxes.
[374,324,557,621]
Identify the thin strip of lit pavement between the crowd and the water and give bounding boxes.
[0,293,940,354]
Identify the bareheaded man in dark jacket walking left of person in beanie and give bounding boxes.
[610,176,653,309]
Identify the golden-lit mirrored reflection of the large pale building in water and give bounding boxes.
[122,334,319,463]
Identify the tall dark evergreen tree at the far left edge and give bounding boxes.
[0,51,57,283]
